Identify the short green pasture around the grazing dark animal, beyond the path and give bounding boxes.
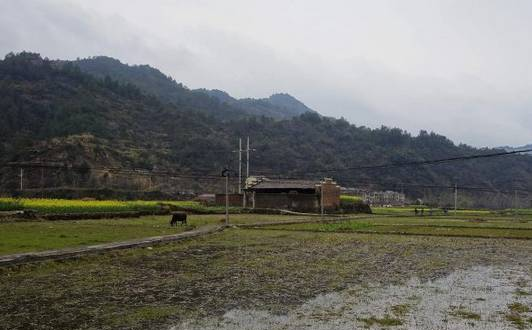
[0,214,312,254]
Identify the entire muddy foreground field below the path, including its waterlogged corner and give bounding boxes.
[0,229,532,330]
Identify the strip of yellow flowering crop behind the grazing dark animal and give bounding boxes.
[0,198,236,213]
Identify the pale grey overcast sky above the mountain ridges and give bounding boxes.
[0,0,532,146]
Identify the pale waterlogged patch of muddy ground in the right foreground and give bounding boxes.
[180,266,532,330]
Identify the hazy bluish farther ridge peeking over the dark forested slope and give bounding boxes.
[72,56,312,119]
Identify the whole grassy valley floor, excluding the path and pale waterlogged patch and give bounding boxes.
[0,211,532,329]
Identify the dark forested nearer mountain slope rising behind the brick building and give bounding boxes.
[0,53,532,206]
